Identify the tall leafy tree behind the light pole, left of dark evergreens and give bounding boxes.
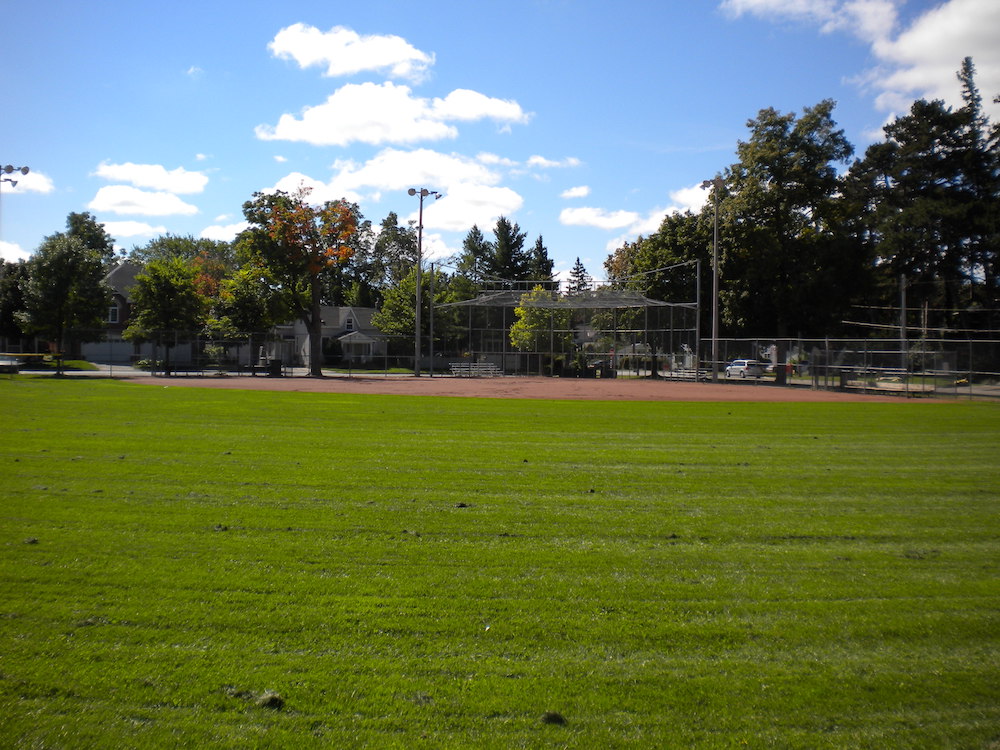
[718,99,857,337]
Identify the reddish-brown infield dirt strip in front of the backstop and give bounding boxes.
[132,375,902,403]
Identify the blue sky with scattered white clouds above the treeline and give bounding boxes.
[0,0,1000,278]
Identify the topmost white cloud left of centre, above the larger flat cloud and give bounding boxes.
[268,23,434,81]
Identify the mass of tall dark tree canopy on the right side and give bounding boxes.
[605,59,1000,344]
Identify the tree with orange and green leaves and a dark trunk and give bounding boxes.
[238,188,358,377]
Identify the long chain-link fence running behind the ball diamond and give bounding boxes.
[11,326,1000,397]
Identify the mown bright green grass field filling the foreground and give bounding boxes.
[0,377,1000,748]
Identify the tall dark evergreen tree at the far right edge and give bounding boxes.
[845,58,1000,329]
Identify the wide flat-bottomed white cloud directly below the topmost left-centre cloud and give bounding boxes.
[255,81,529,146]
